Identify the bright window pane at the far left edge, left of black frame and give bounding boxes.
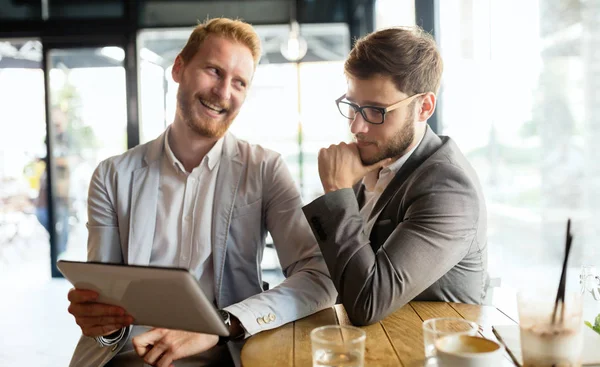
[0,40,50,285]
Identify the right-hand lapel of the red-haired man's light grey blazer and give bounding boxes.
[212,133,244,307]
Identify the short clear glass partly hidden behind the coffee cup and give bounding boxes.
[423,317,479,358]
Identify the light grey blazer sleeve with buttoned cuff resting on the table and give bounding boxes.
[225,155,337,335]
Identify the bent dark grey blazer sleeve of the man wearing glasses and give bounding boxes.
[303,163,479,325]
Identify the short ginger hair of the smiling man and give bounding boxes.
[179,18,261,67]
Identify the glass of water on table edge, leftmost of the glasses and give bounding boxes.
[310,325,367,367]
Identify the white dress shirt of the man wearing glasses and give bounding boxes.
[360,137,423,237]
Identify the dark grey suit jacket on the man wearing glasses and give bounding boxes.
[303,128,487,325]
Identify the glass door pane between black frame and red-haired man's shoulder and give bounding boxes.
[45,46,127,276]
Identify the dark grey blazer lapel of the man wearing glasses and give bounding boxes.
[369,125,442,219]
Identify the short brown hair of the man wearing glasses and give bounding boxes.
[344,26,444,95]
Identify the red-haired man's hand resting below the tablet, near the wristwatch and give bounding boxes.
[132,328,219,367]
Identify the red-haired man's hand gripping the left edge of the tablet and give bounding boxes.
[68,288,133,337]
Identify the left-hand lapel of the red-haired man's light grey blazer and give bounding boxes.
[127,133,165,265]
